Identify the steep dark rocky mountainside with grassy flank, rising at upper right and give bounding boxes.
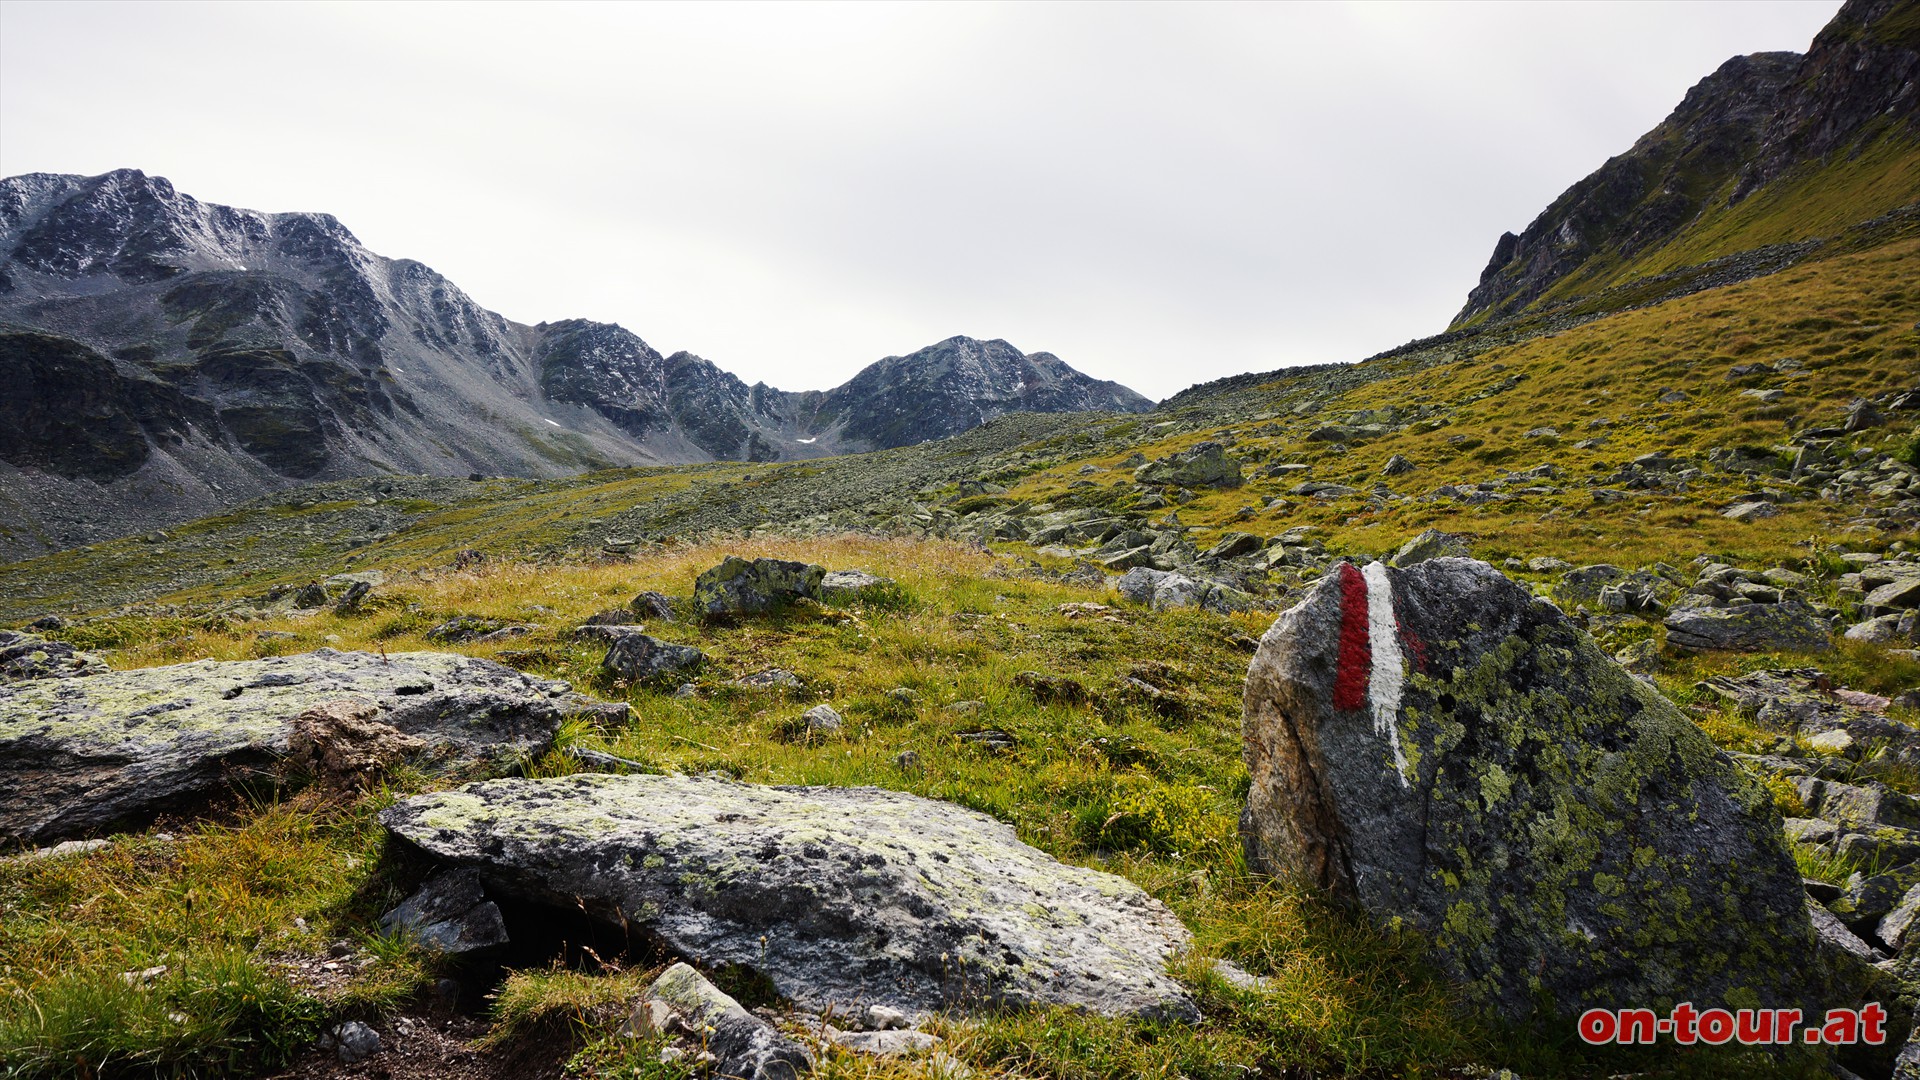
[1453,0,1920,327]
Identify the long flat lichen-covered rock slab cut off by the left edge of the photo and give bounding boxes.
[0,650,589,844]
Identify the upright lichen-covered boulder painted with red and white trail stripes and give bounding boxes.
[1240,557,1839,1017]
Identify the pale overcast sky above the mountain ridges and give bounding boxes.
[0,0,1839,398]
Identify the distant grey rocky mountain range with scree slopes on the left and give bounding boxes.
[0,169,1152,555]
